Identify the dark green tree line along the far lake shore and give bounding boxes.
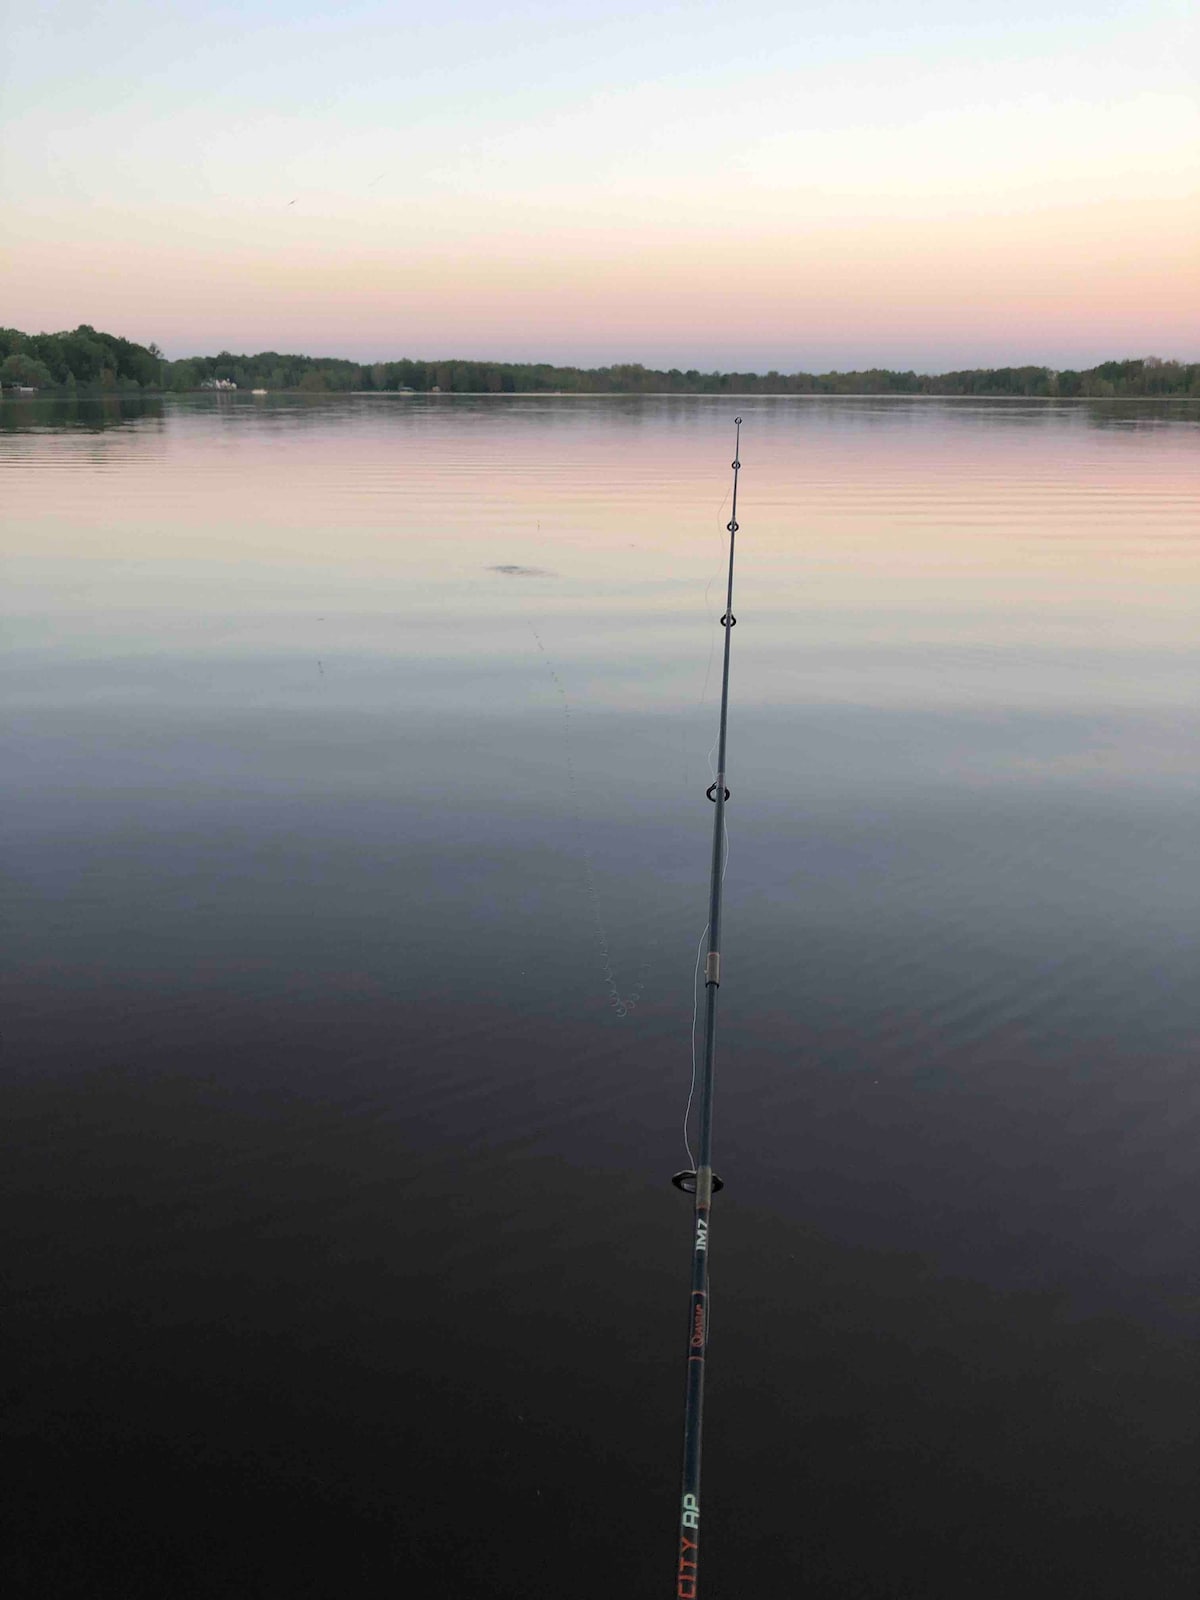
[0,325,1200,398]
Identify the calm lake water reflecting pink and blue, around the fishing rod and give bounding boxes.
[0,395,1200,1600]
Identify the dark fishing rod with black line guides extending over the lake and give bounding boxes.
[670,416,742,1600]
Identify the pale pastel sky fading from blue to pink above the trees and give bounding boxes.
[0,0,1200,371]
